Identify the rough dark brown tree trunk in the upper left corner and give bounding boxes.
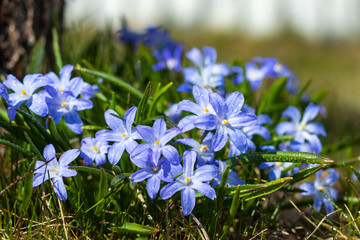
[0,0,65,79]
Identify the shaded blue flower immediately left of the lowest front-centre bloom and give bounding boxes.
[130,155,182,199]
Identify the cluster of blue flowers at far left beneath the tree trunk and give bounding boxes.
[0,65,94,134]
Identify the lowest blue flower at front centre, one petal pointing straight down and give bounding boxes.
[160,150,218,216]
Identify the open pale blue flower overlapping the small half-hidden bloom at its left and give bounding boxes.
[95,107,141,164]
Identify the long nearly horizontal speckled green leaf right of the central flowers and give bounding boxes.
[226,151,334,164]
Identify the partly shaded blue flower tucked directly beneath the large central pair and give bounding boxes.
[176,132,215,166]
